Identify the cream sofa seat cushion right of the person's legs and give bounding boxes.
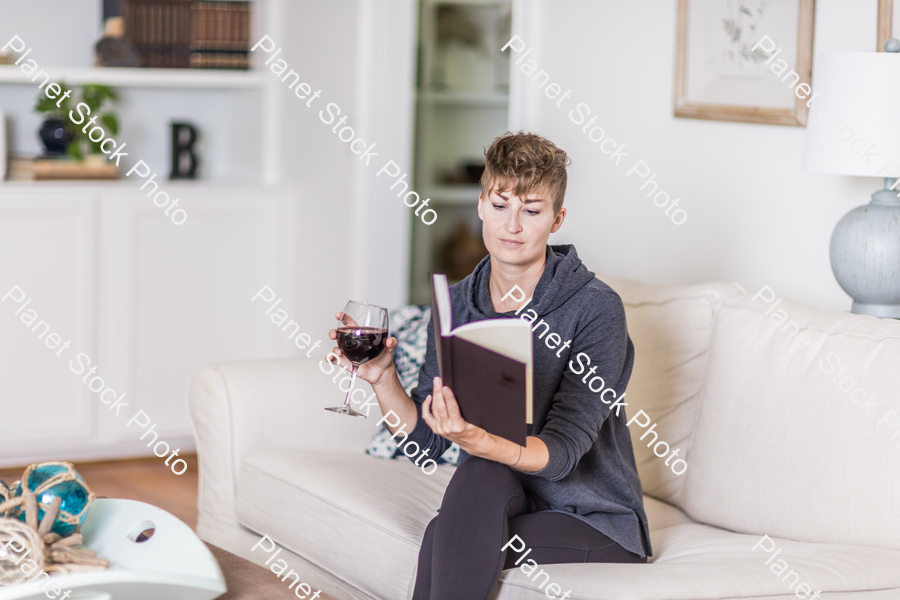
[496,524,900,600]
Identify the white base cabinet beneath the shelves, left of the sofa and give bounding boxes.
[0,182,303,466]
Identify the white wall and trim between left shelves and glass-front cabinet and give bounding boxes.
[270,0,416,340]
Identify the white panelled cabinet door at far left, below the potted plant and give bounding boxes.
[0,191,96,460]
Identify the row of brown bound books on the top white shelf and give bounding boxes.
[123,0,251,70]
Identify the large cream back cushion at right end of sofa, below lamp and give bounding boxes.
[684,294,900,549]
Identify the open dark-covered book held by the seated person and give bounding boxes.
[431,274,533,446]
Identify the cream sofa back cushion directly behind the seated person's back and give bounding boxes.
[599,275,744,507]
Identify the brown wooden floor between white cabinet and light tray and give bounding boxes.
[0,454,198,529]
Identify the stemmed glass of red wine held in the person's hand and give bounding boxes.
[325,300,388,418]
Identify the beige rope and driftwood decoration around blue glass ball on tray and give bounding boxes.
[0,462,109,587]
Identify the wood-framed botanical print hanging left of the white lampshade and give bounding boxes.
[674,0,815,127]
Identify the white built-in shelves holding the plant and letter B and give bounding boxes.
[0,0,284,185]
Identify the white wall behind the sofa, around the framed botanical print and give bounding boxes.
[513,0,882,310]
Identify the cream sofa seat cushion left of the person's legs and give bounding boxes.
[236,450,455,598]
